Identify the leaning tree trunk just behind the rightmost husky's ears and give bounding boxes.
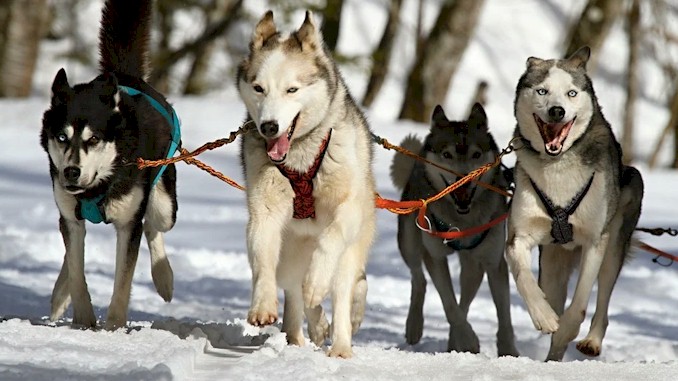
[564,0,625,72]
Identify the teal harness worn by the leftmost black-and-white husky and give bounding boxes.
[79,86,181,224]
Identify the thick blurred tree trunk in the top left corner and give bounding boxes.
[0,0,49,97]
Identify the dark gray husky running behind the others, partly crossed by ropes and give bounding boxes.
[391,103,518,356]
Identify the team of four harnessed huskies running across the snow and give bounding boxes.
[40,0,643,360]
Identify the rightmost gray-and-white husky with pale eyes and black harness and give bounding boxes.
[506,47,643,361]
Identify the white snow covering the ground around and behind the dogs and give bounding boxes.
[0,0,678,380]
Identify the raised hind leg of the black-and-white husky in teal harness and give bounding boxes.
[144,221,174,302]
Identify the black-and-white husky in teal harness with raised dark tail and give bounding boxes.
[41,0,180,329]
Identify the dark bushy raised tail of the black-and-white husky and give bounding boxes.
[99,0,153,79]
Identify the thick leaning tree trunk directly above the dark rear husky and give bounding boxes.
[399,0,484,123]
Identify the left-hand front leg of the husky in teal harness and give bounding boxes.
[57,217,97,328]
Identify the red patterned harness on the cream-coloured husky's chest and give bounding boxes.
[277,130,332,220]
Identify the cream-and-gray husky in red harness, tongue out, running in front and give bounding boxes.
[237,11,376,358]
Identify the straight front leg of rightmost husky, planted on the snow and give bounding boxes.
[546,232,609,361]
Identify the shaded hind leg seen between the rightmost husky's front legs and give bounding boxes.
[539,245,580,316]
